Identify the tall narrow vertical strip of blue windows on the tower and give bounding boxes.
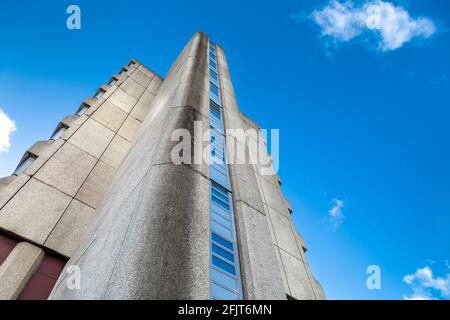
[208,41,243,300]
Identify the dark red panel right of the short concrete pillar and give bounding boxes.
[19,255,66,300]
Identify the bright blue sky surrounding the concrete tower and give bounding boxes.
[0,0,450,299]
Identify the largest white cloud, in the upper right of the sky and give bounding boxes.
[311,0,436,51]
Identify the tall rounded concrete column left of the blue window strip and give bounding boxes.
[50,34,210,299]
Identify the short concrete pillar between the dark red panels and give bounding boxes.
[0,242,44,300]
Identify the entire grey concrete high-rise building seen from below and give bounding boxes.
[0,33,325,300]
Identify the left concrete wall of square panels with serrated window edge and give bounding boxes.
[0,57,162,298]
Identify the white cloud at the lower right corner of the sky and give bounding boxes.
[403,267,450,300]
